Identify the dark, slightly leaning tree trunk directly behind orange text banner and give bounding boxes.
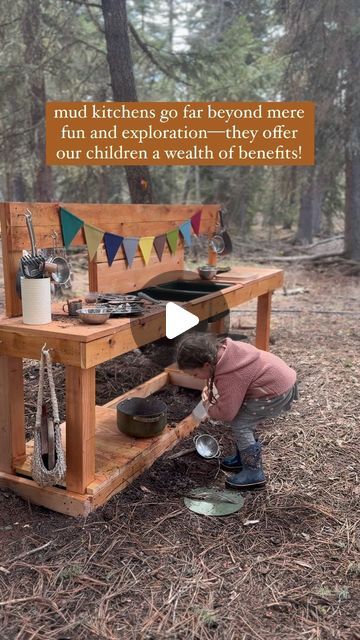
[101,0,153,203]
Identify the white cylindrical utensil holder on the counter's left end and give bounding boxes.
[21,277,51,324]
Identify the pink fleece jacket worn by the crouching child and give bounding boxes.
[208,338,296,421]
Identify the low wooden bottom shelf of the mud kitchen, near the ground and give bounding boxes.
[0,367,203,516]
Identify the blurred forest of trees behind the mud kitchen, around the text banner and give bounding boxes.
[0,0,360,261]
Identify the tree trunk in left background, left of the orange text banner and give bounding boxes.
[21,0,52,202]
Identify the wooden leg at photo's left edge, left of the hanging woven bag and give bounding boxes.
[0,356,26,473]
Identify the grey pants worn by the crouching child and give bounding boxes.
[230,383,298,451]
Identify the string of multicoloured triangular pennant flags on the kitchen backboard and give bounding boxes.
[59,207,202,267]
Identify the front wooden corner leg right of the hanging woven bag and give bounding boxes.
[66,366,95,494]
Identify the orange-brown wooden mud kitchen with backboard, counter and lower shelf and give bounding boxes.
[0,203,283,516]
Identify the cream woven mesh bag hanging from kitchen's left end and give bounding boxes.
[32,345,66,487]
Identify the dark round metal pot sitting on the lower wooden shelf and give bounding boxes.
[116,398,167,438]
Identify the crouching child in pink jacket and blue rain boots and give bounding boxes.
[177,333,297,489]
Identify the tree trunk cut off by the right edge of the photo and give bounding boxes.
[345,0,360,261]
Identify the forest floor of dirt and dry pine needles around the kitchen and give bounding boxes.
[0,252,360,640]
